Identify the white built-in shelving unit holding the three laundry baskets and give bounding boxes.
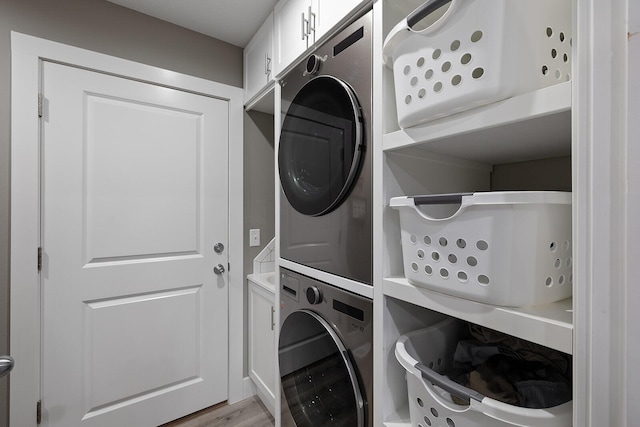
[374,1,574,427]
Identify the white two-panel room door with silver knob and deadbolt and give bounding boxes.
[41,62,229,427]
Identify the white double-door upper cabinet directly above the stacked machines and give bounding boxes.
[274,0,368,75]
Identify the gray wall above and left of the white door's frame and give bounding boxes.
[0,0,242,427]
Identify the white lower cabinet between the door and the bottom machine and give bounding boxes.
[248,274,277,416]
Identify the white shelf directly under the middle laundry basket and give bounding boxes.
[383,278,573,354]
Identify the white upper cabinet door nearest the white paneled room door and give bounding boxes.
[244,13,273,104]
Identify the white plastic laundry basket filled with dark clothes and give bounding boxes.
[395,318,573,427]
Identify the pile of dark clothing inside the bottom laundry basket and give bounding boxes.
[451,325,572,409]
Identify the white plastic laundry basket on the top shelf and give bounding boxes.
[383,0,572,128]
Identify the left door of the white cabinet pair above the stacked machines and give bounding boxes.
[274,0,313,75]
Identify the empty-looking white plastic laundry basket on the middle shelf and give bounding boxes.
[390,191,573,307]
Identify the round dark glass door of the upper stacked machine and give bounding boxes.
[278,76,365,216]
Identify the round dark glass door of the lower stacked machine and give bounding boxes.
[278,310,366,427]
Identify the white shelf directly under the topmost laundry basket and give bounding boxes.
[383,82,571,164]
